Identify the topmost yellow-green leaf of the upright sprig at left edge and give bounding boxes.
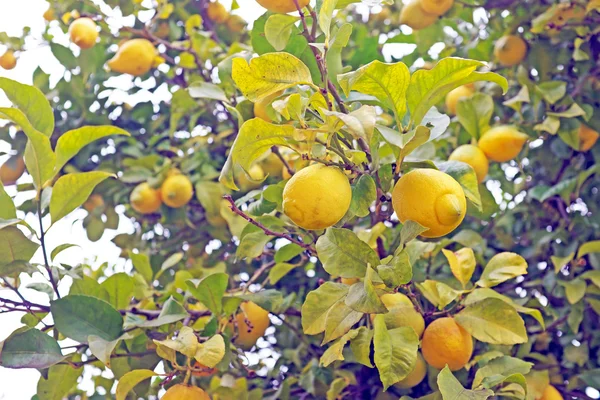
[0,78,54,137]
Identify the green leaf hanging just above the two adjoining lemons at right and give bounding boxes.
[456,93,494,139]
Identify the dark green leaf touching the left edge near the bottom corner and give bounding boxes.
[0,329,64,369]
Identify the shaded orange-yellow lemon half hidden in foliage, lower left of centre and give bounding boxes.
[228,301,271,350]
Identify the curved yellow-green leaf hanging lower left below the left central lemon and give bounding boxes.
[302,282,348,335]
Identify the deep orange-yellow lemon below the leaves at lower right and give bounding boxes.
[421,317,473,371]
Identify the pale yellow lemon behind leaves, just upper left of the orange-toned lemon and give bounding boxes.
[371,293,425,337]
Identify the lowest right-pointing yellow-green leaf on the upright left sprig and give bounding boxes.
[50,171,114,223]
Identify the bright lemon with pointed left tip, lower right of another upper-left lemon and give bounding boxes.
[108,39,158,76]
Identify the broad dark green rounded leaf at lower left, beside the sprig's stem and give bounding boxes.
[50,295,123,343]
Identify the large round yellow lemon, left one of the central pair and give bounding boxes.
[283,164,352,229]
